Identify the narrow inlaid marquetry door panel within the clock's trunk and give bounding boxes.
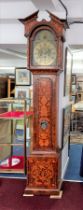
[38,78,52,147]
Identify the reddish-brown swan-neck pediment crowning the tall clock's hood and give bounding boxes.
[19,11,68,39]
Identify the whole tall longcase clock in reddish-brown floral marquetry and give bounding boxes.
[21,12,65,194]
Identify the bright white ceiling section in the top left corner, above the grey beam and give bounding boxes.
[0,0,37,19]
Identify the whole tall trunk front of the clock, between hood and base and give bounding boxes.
[33,75,57,150]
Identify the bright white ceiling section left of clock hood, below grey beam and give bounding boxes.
[0,20,27,44]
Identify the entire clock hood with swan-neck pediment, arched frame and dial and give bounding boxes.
[20,12,66,70]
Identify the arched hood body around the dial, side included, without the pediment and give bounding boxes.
[28,24,63,69]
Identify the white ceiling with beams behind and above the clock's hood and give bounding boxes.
[0,0,83,70]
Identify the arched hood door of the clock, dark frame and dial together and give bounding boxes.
[30,26,58,68]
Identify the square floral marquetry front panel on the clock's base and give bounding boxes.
[27,155,58,189]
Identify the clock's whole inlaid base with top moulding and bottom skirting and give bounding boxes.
[24,153,61,195]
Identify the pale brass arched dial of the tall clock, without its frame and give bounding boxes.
[33,30,57,66]
